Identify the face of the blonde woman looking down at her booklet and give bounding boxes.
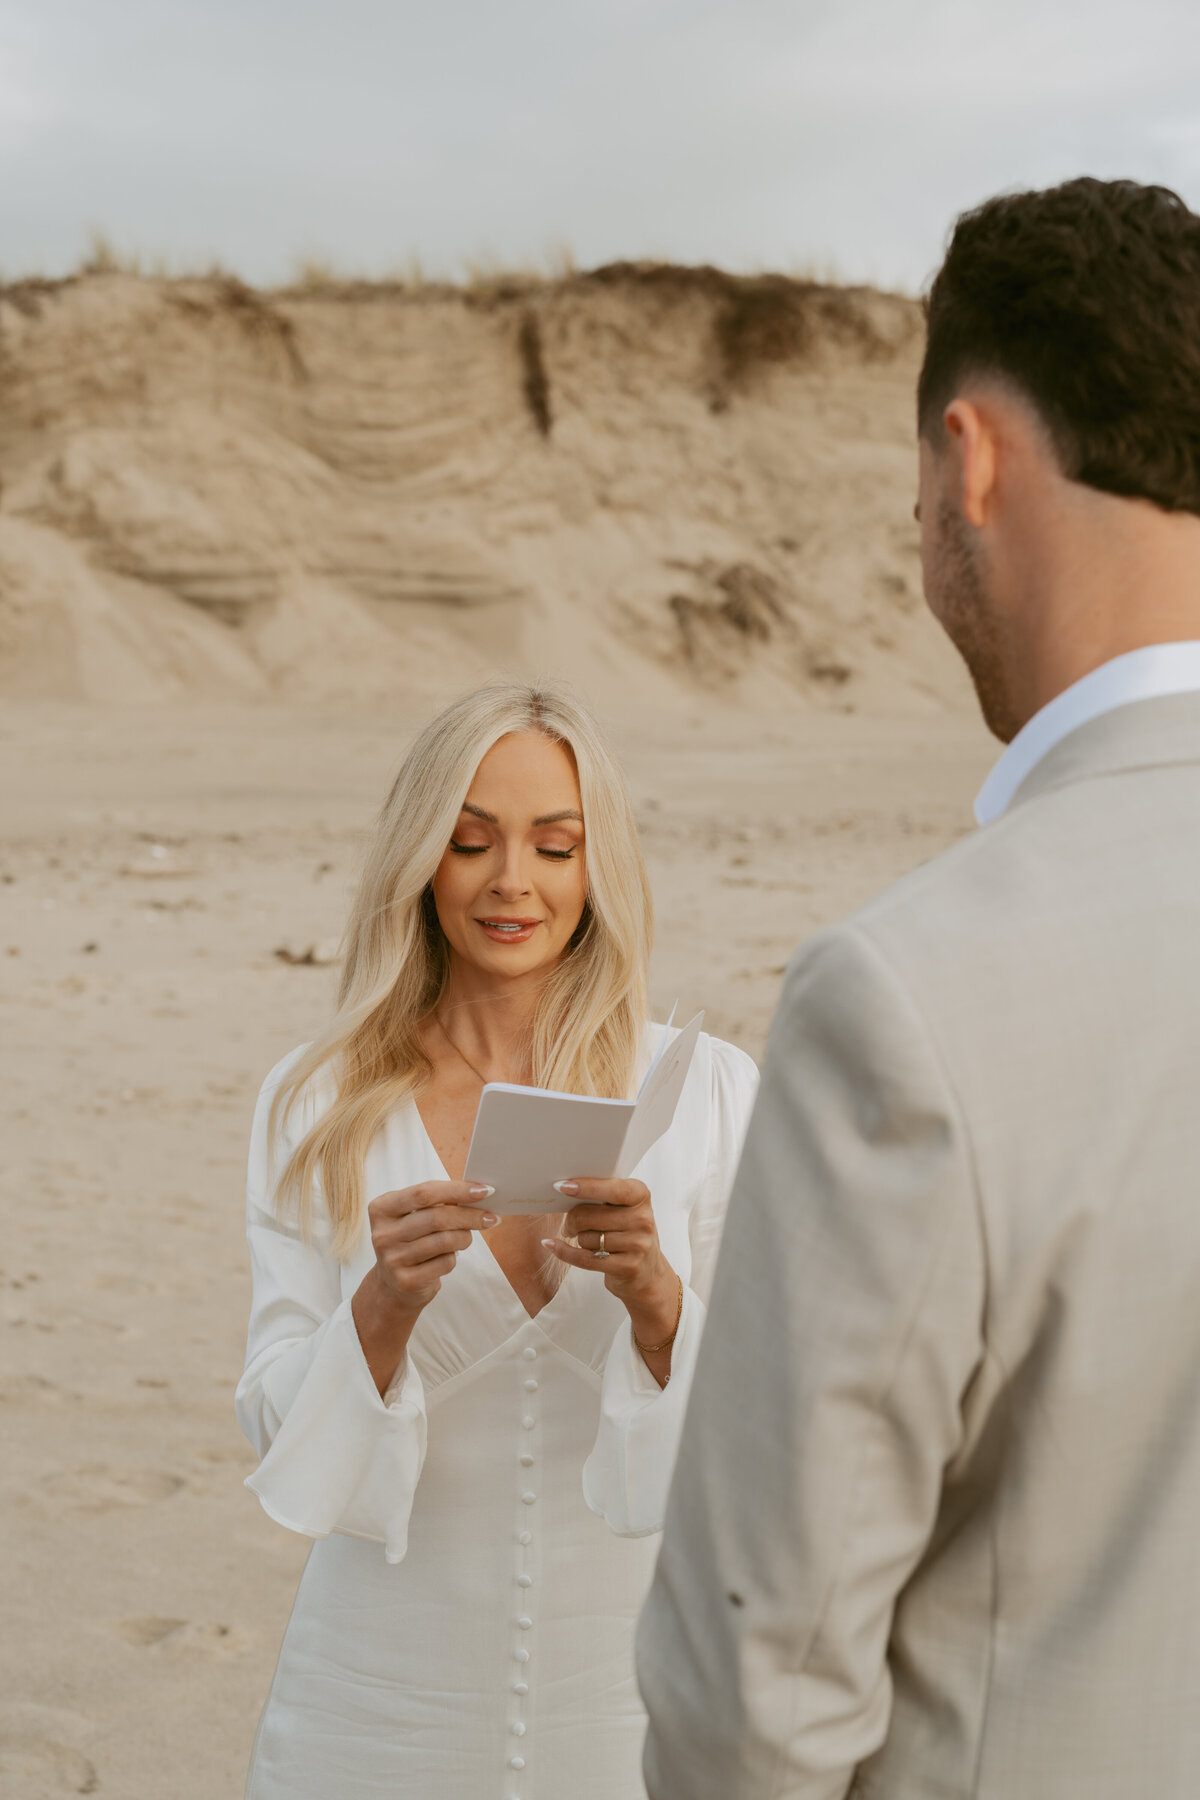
[434,731,587,977]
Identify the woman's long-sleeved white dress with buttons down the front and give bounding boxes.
[237,1028,757,1800]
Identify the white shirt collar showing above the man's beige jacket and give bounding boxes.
[975,639,1200,824]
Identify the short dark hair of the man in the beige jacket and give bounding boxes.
[918,176,1200,513]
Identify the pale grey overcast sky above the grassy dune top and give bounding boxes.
[0,0,1200,288]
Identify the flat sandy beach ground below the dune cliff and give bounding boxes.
[0,707,991,1800]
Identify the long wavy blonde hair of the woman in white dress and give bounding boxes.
[270,680,651,1258]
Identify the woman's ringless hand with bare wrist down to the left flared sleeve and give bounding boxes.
[351,1181,498,1395]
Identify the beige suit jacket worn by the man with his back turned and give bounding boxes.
[639,695,1200,1800]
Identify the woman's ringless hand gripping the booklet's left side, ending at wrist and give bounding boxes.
[367,1181,498,1316]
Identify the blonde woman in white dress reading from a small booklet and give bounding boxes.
[237,684,756,1800]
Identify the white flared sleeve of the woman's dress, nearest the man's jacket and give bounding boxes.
[583,1039,757,1537]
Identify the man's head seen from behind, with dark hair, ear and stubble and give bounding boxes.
[918,178,1200,740]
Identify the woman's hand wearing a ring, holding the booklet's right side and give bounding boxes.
[543,1177,680,1343]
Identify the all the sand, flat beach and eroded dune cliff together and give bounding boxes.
[0,274,993,1800]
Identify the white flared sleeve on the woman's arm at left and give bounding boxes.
[236,1062,425,1562]
